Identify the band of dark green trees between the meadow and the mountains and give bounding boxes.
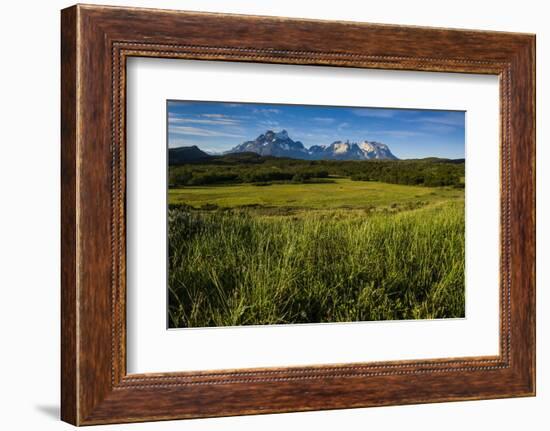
[169,153,464,187]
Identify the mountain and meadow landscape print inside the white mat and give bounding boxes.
[167,100,465,328]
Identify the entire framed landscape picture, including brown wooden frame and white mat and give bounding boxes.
[61,5,535,425]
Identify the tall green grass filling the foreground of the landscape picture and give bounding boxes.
[169,202,464,327]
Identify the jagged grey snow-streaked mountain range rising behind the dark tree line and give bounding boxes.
[227,130,397,160]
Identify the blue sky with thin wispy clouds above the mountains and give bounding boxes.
[167,100,465,159]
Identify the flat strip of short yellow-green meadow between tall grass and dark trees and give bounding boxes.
[168,178,464,209]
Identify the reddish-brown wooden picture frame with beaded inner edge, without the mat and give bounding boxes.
[61,5,535,425]
